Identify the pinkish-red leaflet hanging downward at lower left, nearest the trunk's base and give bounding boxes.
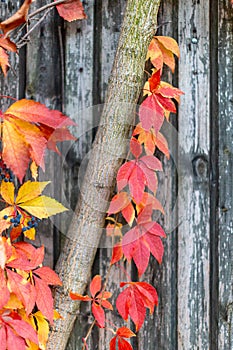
[34,276,53,324]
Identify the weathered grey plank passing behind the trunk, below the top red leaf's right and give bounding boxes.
[61,0,97,350]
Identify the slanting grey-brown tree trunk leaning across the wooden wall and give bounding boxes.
[47,0,160,350]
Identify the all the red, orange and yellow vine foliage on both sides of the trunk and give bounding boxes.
[0,0,183,350]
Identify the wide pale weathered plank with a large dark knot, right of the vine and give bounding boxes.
[177,0,210,350]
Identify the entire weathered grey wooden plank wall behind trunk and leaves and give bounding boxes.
[1,0,233,350]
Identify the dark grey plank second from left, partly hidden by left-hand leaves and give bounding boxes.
[26,1,61,267]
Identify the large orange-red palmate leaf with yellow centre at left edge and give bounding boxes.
[1,99,75,182]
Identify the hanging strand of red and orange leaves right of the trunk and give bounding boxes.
[70,36,183,350]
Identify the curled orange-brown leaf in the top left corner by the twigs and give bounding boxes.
[0,0,32,36]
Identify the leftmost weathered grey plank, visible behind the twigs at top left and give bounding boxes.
[0,1,21,111]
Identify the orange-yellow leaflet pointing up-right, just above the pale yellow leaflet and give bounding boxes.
[15,181,50,205]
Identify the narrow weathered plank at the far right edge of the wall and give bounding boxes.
[218,0,233,349]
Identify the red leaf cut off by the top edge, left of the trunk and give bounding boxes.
[54,0,87,22]
